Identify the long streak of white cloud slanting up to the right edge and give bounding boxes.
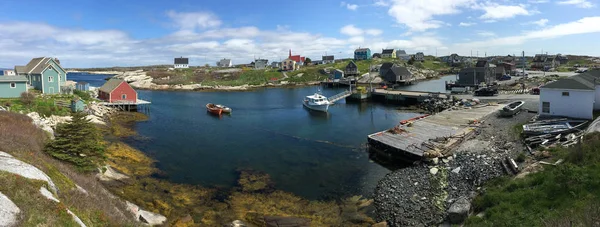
[457,16,600,48]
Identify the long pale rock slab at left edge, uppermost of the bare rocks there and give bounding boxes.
[0,151,58,193]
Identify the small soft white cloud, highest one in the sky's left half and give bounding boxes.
[167,10,221,30]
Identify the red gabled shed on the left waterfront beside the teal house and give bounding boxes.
[98,79,138,103]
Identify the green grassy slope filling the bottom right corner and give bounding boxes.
[467,134,600,226]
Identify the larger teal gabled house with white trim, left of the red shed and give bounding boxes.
[15,57,67,94]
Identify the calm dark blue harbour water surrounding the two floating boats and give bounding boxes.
[69,73,444,199]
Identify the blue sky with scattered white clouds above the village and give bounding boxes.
[0,0,600,68]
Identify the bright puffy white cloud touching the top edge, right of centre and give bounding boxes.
[388,0,475,31]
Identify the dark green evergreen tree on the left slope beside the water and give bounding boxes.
[44,112,105,171]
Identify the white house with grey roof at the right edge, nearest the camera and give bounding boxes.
[539,70,600,119]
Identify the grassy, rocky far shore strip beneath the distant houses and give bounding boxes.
[69,56,456,91]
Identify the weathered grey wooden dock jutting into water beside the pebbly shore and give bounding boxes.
[367,105,502,161]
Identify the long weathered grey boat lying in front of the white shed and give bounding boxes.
[523,120,588,136]
